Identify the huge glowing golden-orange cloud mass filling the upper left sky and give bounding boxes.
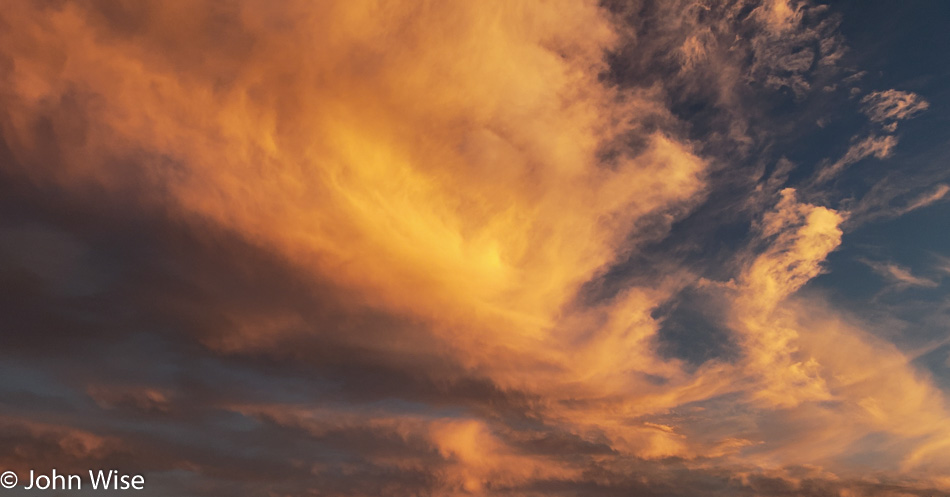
[4,0,703,342]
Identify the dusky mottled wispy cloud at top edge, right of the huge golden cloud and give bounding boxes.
[605,0,847,162]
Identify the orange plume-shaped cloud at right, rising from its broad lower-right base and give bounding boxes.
[716,189,950,478]
